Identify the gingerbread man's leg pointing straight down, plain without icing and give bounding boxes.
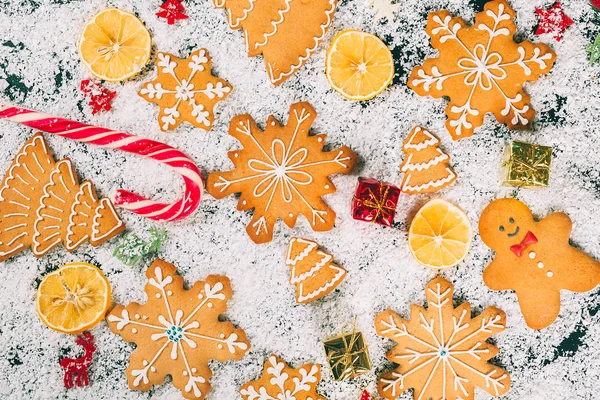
[517,287,560,329]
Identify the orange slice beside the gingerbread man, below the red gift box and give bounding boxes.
[408,199,473,269]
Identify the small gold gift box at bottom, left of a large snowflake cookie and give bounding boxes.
[324,320,371,381]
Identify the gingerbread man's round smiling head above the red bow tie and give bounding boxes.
[479,199,534,250]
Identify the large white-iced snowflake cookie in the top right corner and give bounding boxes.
[408,0,556,140]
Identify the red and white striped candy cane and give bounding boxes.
[0,104,203,221]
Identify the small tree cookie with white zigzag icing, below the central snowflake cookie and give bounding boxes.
[285,238,346,304]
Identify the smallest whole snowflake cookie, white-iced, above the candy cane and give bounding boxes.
[139,49,232,131]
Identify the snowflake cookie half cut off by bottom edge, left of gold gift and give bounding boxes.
[240,354,327,400]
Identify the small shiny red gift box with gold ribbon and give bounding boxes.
[352,178,400,226]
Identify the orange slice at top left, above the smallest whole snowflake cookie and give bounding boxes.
[79,8,152,82]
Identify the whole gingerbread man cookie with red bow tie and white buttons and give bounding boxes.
[479,199,600,329]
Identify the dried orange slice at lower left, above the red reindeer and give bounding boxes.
[36,262,111,334]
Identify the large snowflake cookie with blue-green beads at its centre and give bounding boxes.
[106,260,250,400]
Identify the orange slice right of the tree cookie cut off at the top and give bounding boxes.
[325,29,394,100]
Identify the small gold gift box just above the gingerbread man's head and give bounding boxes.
[503,141,552,187]
